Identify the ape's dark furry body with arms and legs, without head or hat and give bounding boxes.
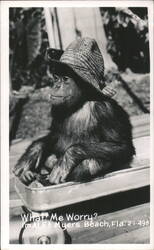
[14,76,135,184]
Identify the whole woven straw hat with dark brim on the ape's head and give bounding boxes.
[47,37,115,97]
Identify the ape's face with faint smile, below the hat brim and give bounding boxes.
[49,74,82,107]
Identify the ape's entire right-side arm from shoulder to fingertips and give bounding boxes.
[50,100,135,183]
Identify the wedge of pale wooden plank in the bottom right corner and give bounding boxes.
[97,227,150,244]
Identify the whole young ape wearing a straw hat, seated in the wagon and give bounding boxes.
[14,38,135,184]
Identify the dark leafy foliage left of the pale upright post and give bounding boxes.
[10,8,49,90]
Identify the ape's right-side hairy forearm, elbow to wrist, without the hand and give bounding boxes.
[63,142,134,168]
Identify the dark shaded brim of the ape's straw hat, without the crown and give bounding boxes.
[48,59,106,97]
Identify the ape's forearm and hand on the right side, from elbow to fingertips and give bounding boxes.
[50,142,134,184]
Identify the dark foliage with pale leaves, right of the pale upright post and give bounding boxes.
[101,7,149,73]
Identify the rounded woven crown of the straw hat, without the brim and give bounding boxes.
[60,37,104,89]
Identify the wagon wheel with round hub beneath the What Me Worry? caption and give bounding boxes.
[19,217,67,244]
